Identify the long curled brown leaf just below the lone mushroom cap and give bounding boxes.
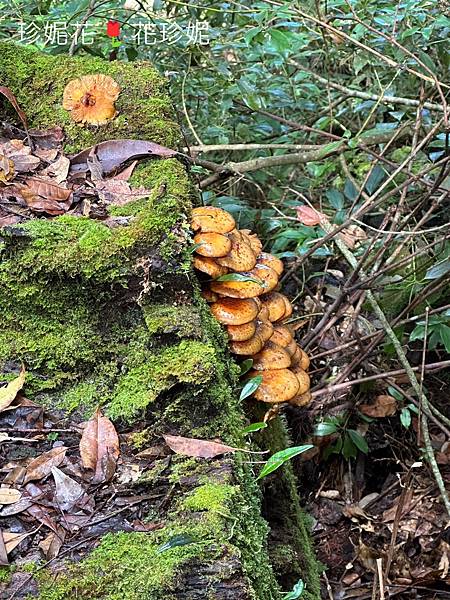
[70,140,177,174]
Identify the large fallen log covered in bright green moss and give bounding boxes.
[0,43,320,600]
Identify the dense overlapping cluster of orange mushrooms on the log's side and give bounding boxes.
[191,206,311,406]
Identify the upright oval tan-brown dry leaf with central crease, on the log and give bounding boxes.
[80,410,120,483]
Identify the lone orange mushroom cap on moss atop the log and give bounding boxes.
[63,74,120,125]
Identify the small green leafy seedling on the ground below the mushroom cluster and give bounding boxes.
[314,414,370,460]
